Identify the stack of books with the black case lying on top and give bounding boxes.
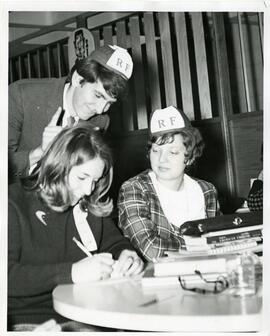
[180,212,263,254]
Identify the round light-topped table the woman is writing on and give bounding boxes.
[53,279,262,332]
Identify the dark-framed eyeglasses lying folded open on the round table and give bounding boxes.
[178,270,229,294]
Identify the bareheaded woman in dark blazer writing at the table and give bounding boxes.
[8,126,143,330]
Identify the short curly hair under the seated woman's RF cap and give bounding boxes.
[147,127,204,165]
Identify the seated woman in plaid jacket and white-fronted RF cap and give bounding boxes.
[118,106,220,260]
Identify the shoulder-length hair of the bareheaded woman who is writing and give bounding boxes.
[24,125,112,216]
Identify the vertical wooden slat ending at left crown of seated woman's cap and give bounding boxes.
[143,13,161,111]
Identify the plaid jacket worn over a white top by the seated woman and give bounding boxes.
[118,170,221,260]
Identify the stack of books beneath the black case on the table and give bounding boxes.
[180,225,263,254]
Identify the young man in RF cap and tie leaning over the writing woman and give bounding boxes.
[8,45,133,181]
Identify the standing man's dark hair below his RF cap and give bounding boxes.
[66,57,127,99]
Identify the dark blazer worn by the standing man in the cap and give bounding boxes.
[8,78,109,177]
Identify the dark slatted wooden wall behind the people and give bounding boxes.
[9,12,263,213]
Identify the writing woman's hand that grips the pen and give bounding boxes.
[71,253,114,283]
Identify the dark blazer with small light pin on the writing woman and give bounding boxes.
[8,183,134,326]
